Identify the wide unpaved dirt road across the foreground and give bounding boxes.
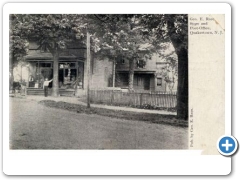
[10,98,188,149]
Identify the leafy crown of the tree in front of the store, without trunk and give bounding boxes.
[10,14,86,53]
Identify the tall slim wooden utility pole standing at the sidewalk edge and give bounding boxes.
[87,32,91,108]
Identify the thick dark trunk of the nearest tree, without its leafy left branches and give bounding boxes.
[167,15,188,120]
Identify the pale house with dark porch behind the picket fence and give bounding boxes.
[116,54,177,92]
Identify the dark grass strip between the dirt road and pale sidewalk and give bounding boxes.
[39,100,188,127]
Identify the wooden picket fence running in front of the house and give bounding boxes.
[90,90,177,108]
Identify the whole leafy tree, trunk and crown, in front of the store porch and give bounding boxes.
[10,14,87,96]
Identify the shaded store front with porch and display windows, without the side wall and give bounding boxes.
[13,41,86,94]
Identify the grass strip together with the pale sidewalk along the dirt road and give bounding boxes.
[15,96,188,127]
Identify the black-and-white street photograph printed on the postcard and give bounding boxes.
[9,14,188,150]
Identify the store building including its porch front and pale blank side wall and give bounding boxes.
[13,41,113,96]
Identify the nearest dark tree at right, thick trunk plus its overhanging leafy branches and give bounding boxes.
[141,14,188,120]
